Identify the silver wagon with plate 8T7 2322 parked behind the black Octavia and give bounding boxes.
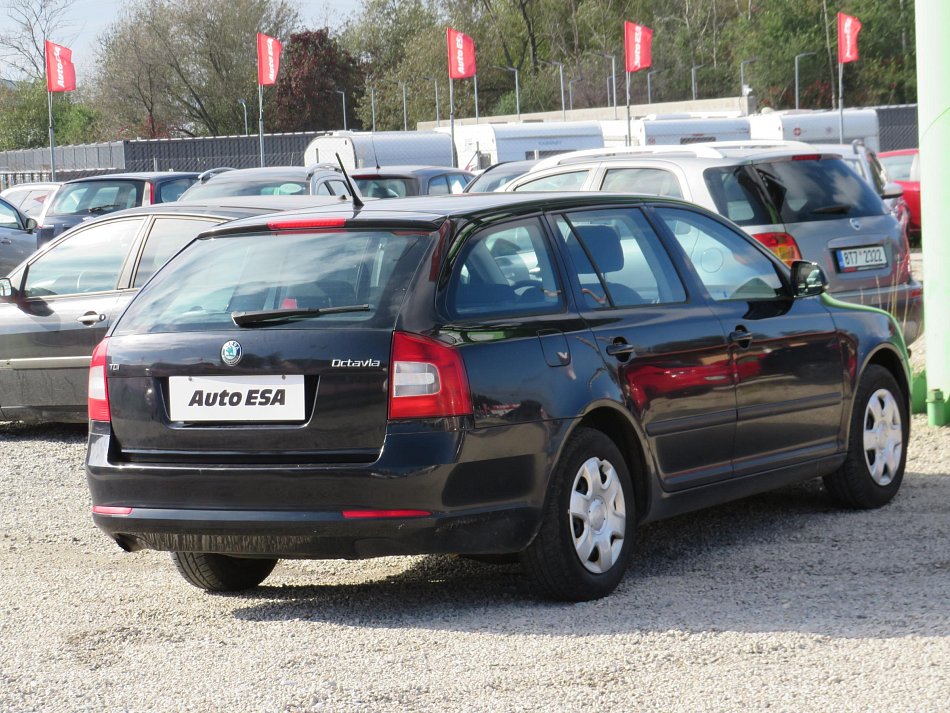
[505,141,923,344]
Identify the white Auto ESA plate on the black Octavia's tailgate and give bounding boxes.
[168,374,305,422]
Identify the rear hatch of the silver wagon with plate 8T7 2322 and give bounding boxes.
[704,154,909,292]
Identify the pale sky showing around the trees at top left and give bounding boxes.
[0,0,363,82]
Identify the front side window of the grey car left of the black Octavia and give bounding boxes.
[23,218,145,297]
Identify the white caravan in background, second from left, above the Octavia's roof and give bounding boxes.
[435,121,604,171]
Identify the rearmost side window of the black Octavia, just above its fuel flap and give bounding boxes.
[446,220,564,318]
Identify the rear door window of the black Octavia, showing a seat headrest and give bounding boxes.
[557,208,686,309]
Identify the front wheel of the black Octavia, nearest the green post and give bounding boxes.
[823,365,910,509]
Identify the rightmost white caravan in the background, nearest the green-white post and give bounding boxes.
[749,109,880,151]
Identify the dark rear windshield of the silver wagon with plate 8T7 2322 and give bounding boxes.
[755,159,885,224]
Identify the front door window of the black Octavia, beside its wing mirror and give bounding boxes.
[656,208,786,301]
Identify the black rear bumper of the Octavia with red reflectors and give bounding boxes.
[86,422,557,559]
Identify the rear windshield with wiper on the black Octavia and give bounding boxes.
[116,230,429,334]
